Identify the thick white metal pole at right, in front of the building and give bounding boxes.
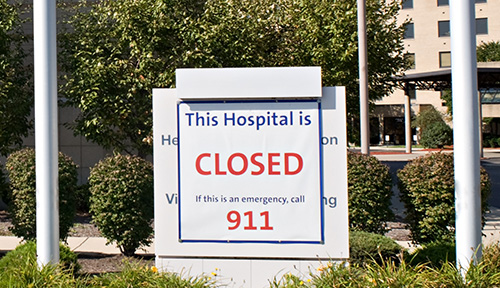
[450,0,481,276]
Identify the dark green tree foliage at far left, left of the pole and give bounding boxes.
[0,0,33,156]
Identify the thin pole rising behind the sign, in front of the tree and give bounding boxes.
[358,0,370,155]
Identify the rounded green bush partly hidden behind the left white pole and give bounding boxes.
[5,148,78,240]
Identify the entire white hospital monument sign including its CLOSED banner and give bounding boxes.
[153,67,349,287]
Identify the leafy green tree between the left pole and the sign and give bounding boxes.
[60,0,202,156]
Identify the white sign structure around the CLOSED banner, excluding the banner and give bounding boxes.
[153,67,349,287]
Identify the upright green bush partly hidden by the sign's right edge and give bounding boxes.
[347,153,394,234]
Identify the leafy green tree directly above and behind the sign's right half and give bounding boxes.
[195,0,409,142]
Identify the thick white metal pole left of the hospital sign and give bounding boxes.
[33,0,59,267]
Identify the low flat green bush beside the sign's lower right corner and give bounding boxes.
[349,231,403,264]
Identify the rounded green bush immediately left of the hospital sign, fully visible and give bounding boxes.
[89,155,153,255]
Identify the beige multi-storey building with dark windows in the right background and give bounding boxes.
[371,0,500,144]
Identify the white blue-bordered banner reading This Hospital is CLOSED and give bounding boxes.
[178,100,324,243]
